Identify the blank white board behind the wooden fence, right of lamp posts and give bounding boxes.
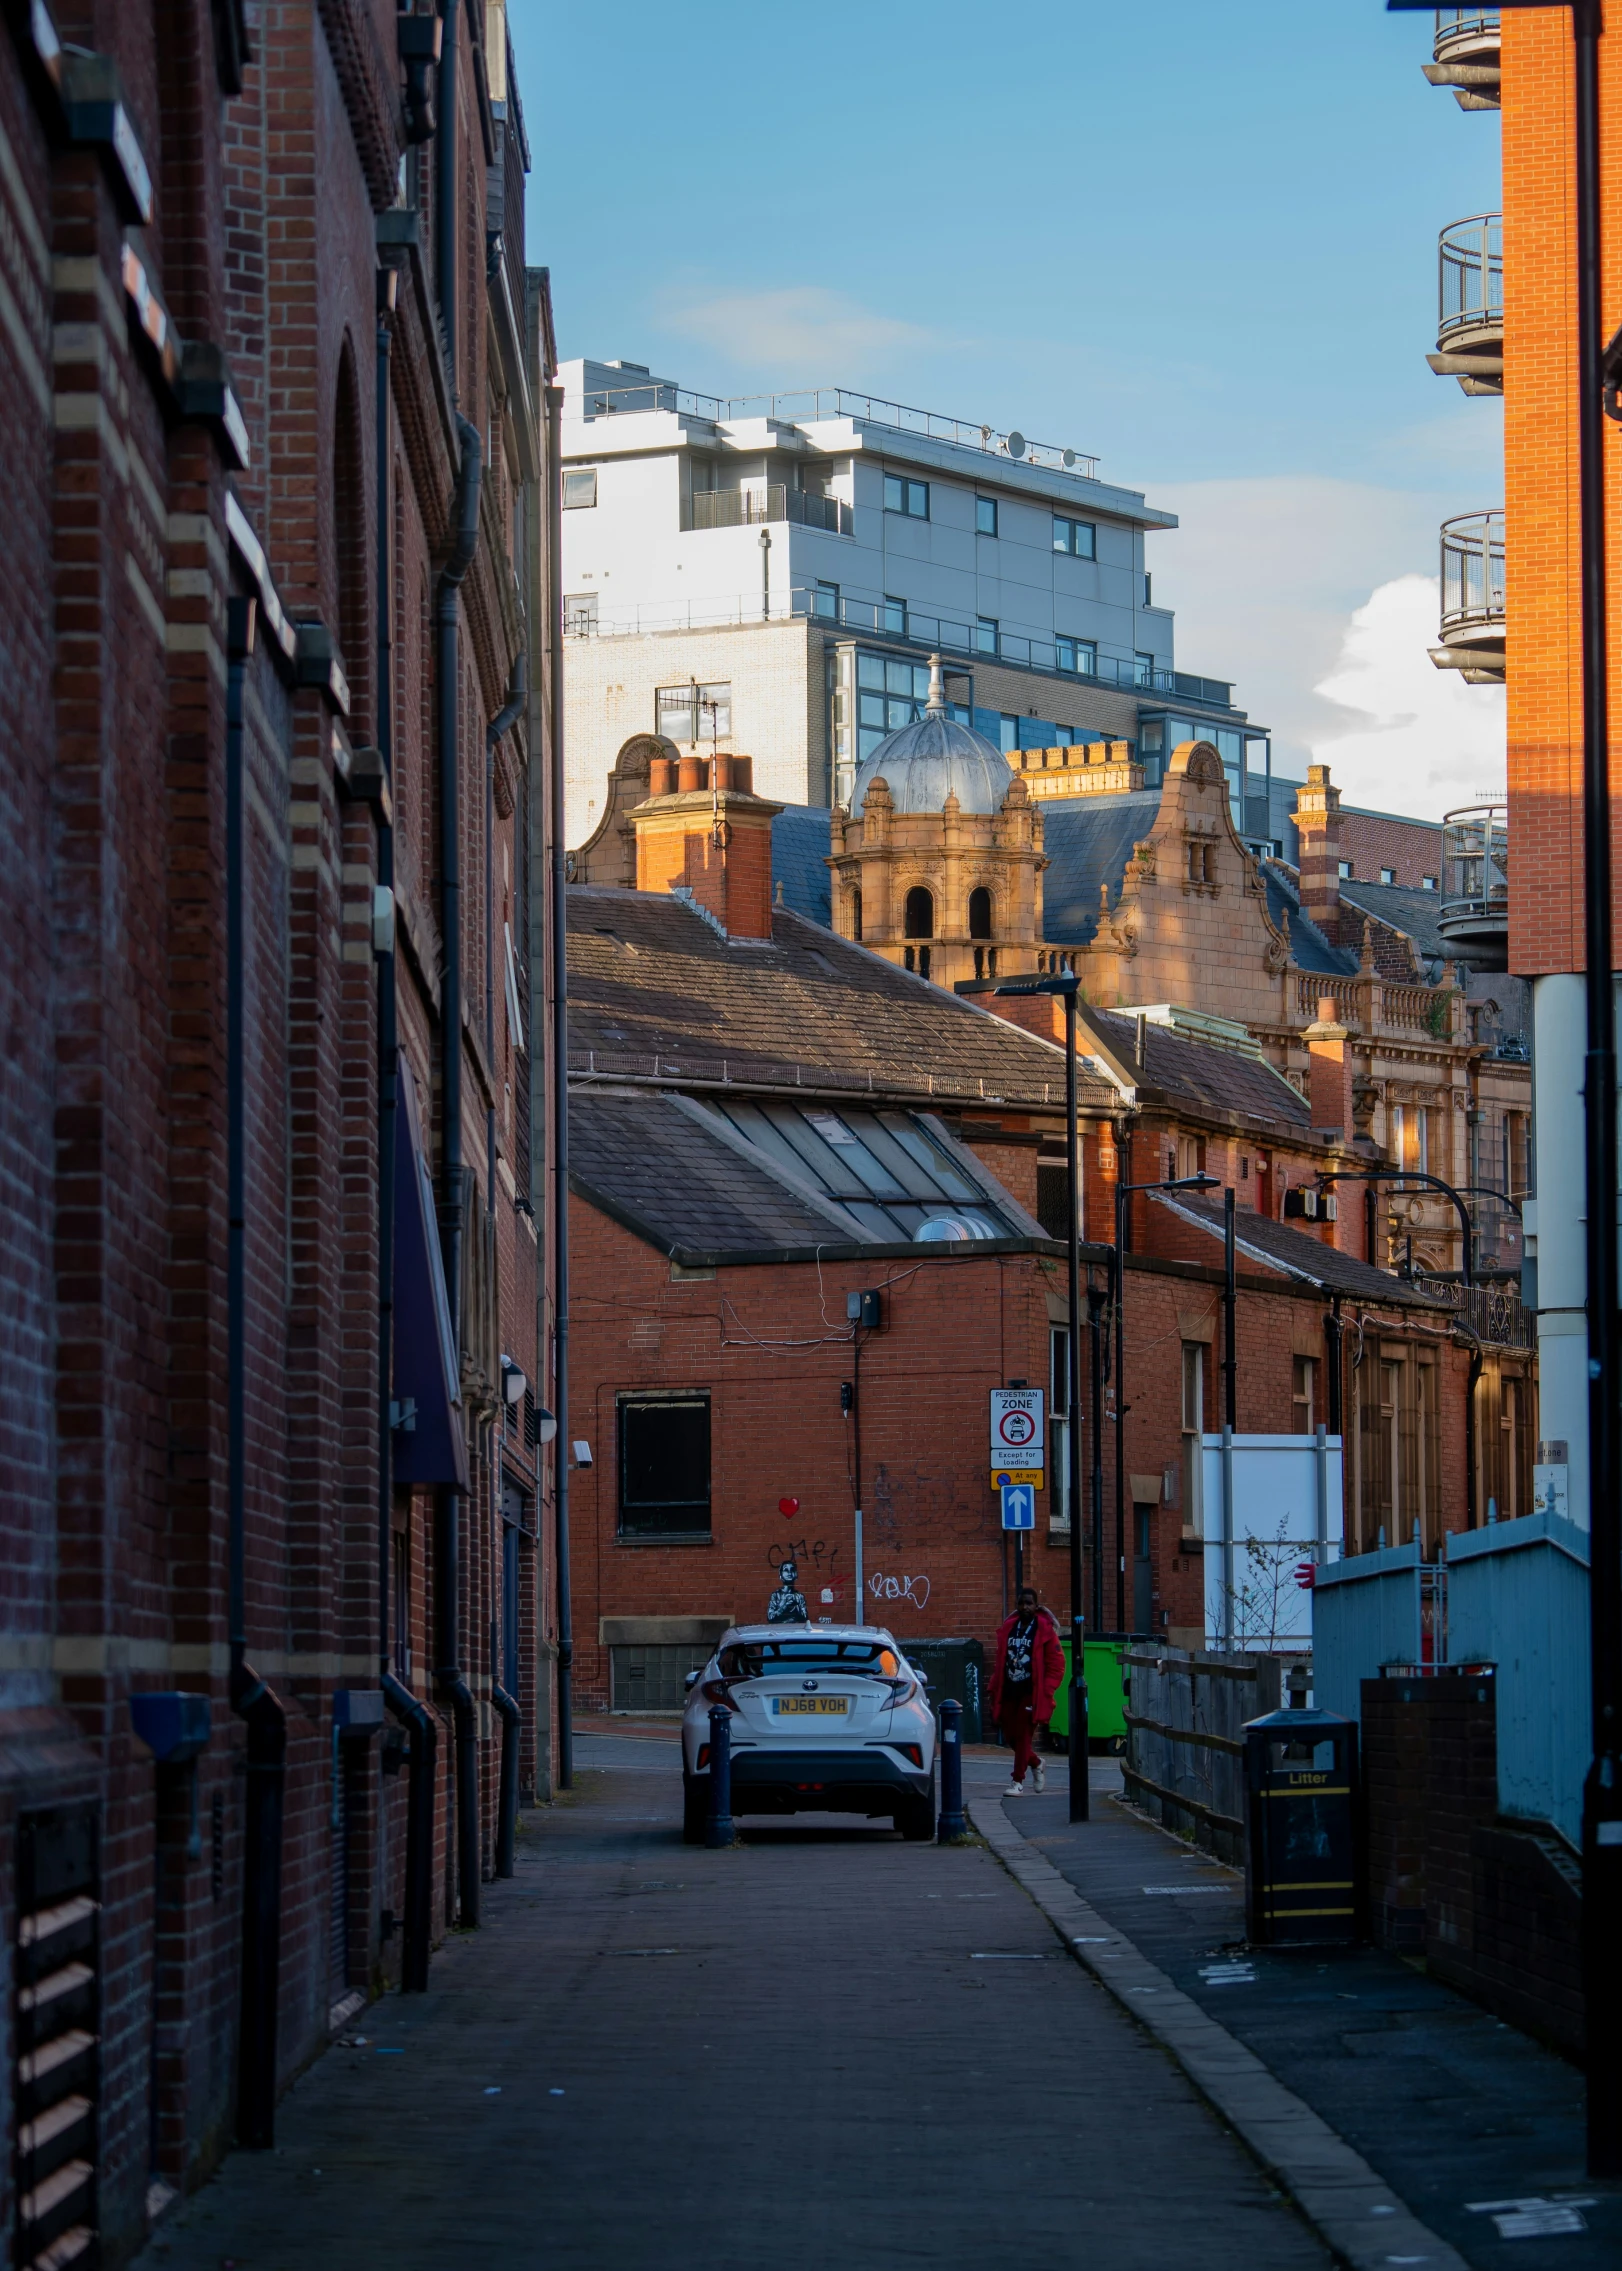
[1199,1435,1345,1653]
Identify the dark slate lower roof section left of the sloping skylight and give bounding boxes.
[568,1088,854,1254]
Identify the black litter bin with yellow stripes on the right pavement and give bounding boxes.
[1245,1710,1363,1946]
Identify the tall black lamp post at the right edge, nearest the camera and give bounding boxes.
[1386,0,1622,2176]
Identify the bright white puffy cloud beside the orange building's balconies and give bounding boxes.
[1313,575,1506,820]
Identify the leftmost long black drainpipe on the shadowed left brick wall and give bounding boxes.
[225,600,286,2148]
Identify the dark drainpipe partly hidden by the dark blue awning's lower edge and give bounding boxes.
[434,408,484,1924]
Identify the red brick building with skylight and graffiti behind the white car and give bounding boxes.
[568,781,1472,1708]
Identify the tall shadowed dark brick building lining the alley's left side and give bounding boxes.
[0,0,554,2264]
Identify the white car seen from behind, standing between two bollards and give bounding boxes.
[682,1624,936,1844]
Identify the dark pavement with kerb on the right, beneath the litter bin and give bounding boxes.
[981,1769,1622,2271]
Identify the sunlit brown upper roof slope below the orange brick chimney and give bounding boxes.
[566,883,1118,1111]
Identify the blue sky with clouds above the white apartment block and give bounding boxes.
[509,0,1502,808]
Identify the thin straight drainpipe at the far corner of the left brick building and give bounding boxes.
[545,386,574,1790]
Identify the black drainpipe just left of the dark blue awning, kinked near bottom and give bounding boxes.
[377,270,438,1994]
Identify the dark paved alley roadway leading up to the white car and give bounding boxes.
[141,1735,1329,2271]
